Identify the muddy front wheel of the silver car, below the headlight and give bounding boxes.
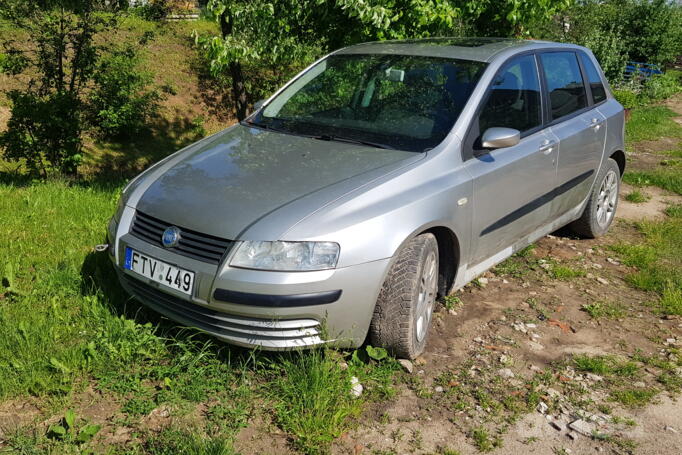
[369,234,438,359]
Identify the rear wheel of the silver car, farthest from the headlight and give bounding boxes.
[569,158,620,239]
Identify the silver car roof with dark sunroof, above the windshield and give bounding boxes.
[335,37,579,62]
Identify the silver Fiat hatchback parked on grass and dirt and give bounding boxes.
[108,38,625,358]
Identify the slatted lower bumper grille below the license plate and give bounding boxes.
[124,275,322,347]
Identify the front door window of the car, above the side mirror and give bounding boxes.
[479,55,542,134]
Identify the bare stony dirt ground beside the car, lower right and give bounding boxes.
[334,219,682,454]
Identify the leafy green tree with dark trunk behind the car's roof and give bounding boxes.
[195,0,570,119]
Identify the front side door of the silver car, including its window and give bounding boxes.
[464,54,557,265]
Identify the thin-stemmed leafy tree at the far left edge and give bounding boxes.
[0,0,111,177]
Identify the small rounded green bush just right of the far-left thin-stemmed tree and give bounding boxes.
[89,47,161,138]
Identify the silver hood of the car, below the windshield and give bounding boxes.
[136,125,421,240]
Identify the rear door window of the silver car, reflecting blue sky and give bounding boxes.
[540,52,587,120]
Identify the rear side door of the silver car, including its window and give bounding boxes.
[539,51,606,219]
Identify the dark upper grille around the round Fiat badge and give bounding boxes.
[130,211,233,264]
